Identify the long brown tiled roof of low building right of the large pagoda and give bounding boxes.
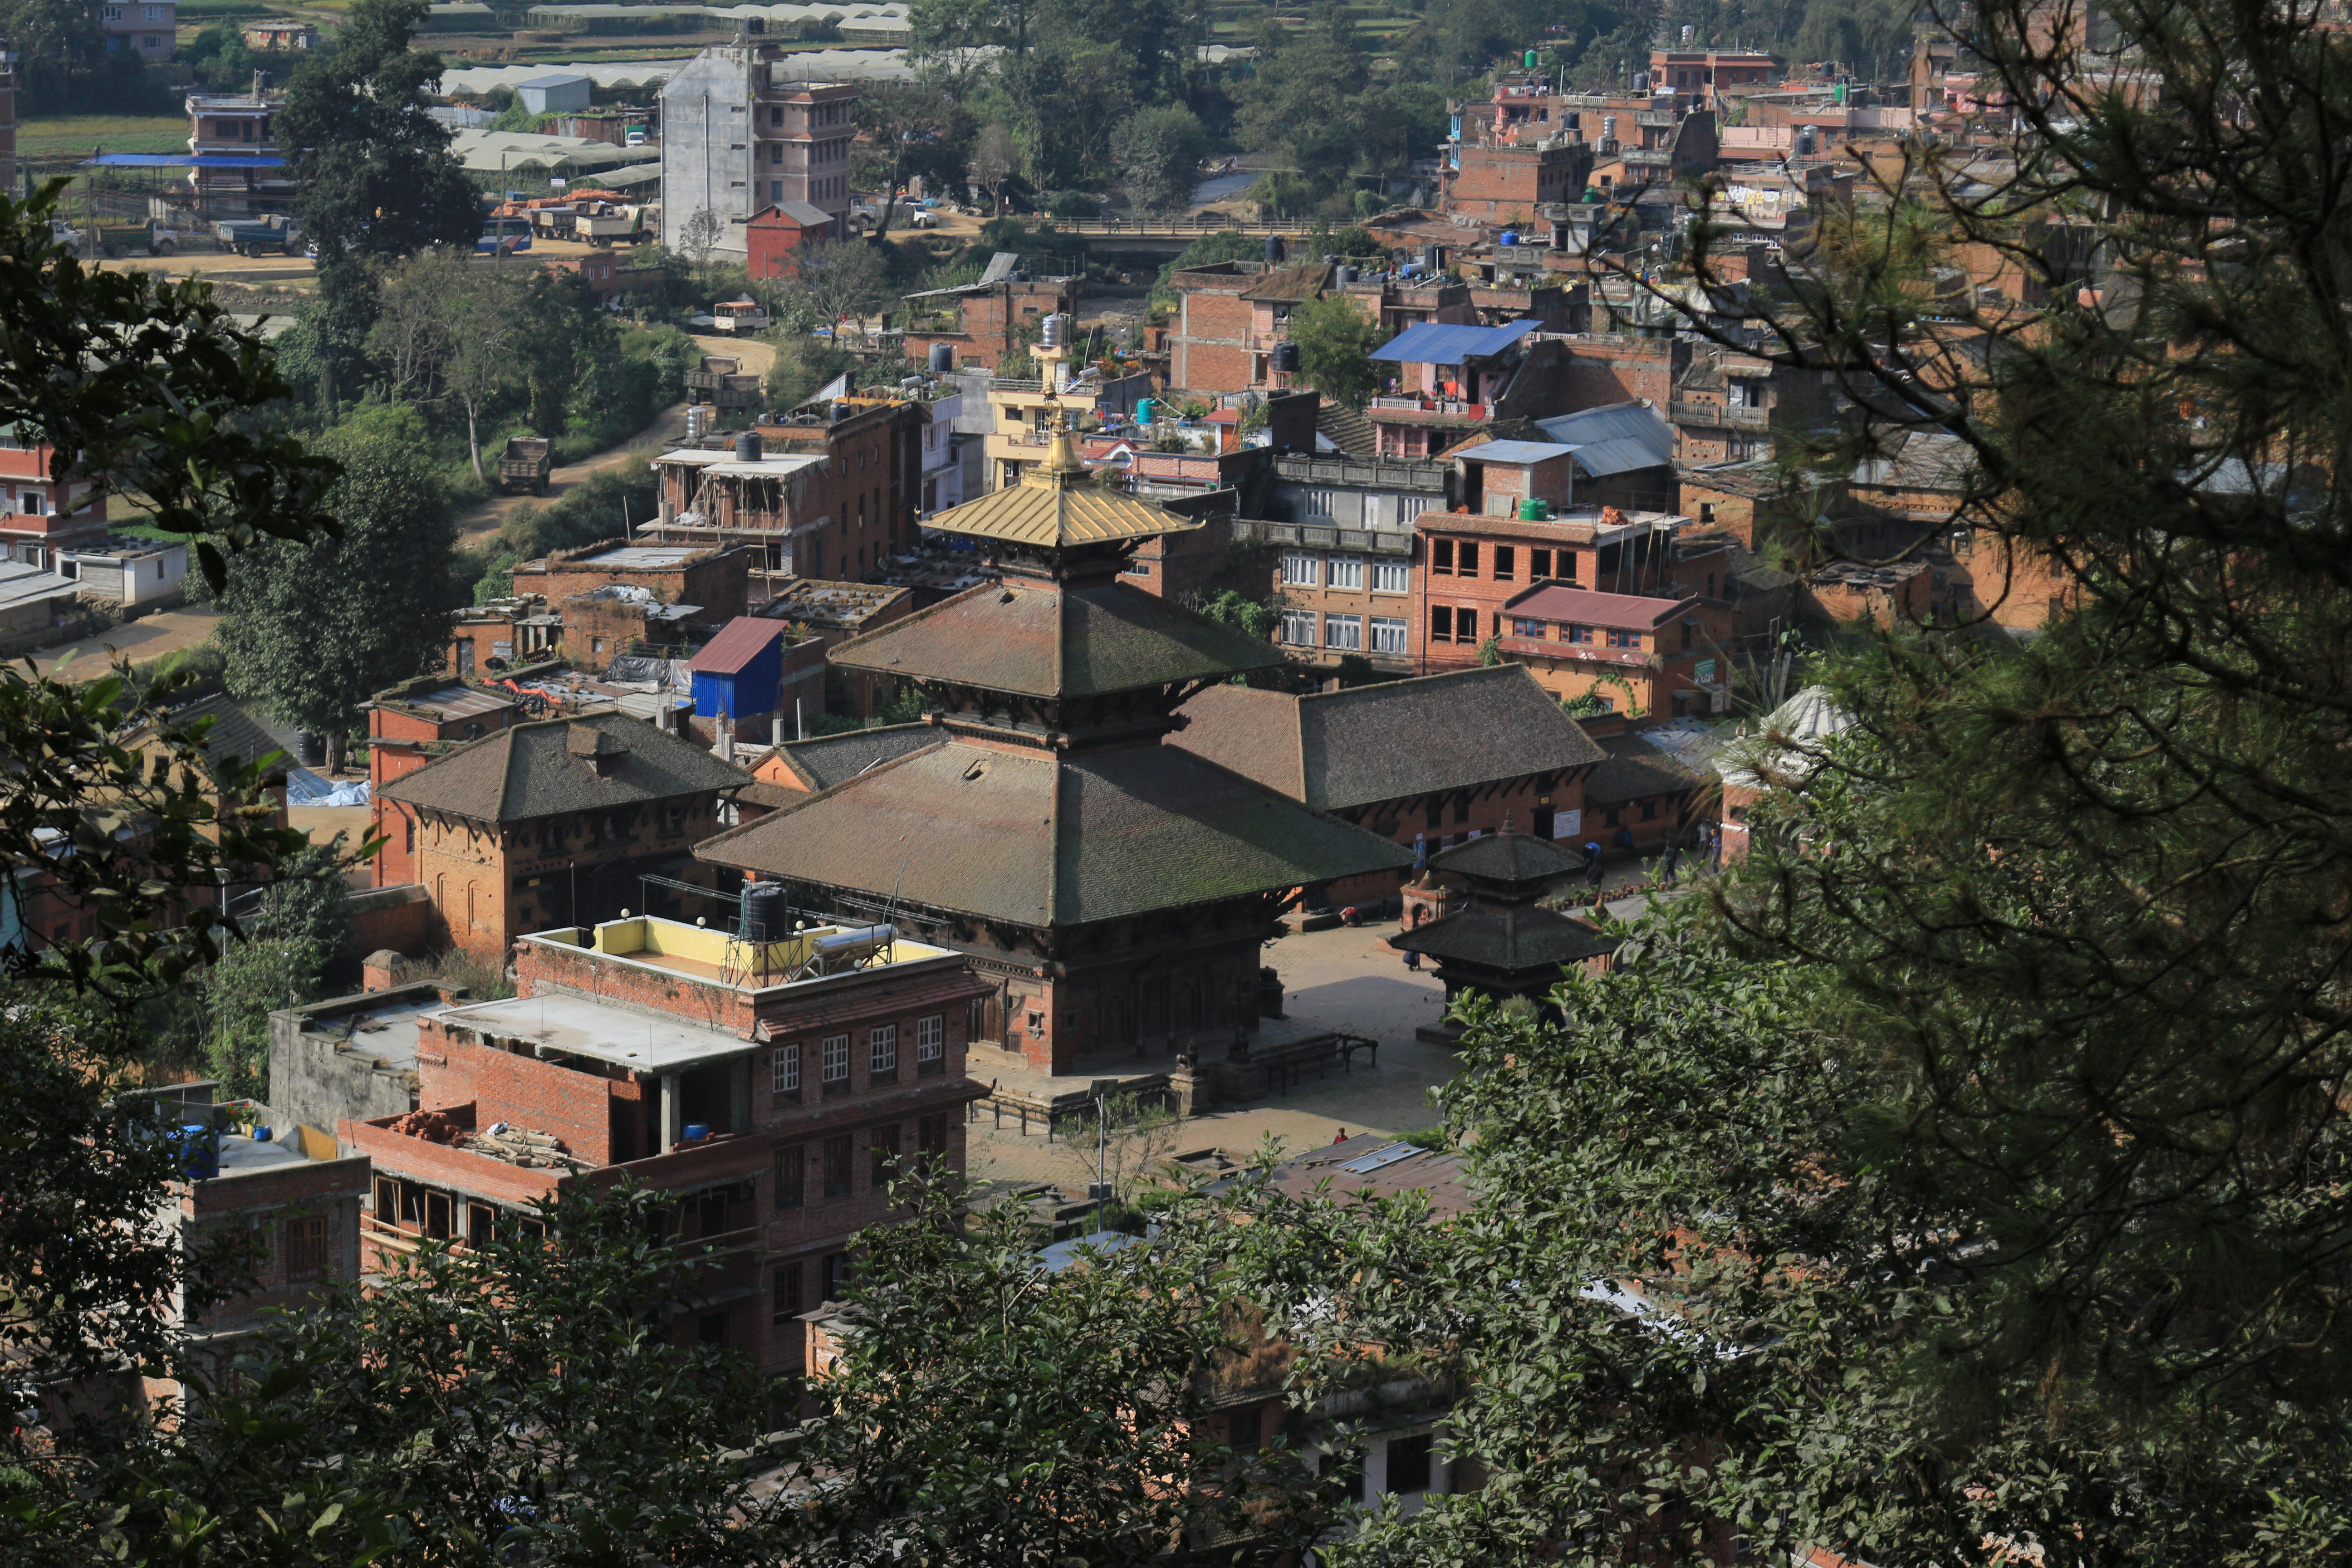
[1176,665,1602,811]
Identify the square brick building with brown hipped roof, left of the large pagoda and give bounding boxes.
[369,703,750,961]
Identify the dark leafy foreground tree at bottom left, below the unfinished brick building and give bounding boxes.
[18,1187,779,1563]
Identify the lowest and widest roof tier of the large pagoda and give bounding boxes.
[694,740,1411,926]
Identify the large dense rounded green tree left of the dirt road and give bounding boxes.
[216,407,468,764]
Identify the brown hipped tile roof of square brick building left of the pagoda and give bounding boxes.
[383,712,750,823]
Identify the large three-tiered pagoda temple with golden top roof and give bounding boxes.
[696,423,1411,1072]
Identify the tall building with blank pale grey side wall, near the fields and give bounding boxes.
[661,34,858,256]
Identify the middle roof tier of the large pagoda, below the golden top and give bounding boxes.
[830,578,1282,696]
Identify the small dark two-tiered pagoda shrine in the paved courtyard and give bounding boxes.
[1388,820,1618,1046]
